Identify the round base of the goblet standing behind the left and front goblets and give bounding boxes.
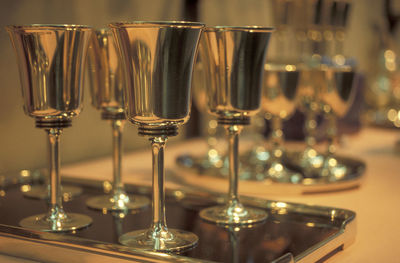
[86,194,150,211]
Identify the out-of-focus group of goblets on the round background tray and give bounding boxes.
[178,0,357,188]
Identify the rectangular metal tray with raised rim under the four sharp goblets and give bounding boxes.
[0,176,356,263]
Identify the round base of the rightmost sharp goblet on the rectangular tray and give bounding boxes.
[200,206,268,225]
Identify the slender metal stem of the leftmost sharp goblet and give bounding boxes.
[46,128,64,219]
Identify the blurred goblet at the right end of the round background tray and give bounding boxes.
[320,66,357,181]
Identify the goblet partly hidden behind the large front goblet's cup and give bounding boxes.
[86,29,150,211]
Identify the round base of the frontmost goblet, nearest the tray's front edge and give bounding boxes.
[119,229,199,252]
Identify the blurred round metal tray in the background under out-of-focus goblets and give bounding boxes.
[176,152,366,195]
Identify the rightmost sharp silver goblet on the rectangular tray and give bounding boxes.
[200,27,273,225]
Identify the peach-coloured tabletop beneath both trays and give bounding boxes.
[0,128,400,263]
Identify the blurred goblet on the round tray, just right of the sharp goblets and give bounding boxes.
[262,63,302,183]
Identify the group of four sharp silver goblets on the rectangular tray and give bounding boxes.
[7,22,282,254]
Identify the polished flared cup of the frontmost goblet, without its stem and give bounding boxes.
[110,22,203,126]
